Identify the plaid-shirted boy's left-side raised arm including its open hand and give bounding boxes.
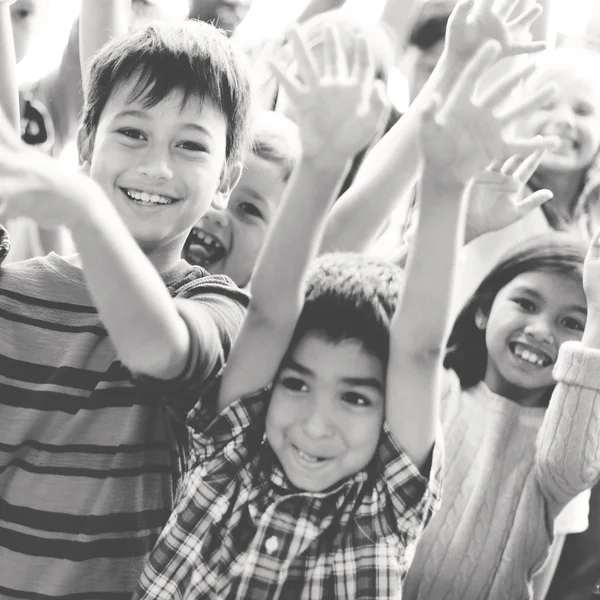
[219,29,384,410]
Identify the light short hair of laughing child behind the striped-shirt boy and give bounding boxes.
[251,110,302,182]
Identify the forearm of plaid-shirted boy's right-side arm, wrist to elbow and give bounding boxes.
[392,170,467,357]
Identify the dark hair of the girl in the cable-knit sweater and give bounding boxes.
[444,232,587,393]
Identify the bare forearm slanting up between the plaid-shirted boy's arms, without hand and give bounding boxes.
[322,52,462,252]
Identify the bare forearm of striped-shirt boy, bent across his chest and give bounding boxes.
[71,182,190,379]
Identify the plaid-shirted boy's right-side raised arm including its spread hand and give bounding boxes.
[386,42,543,467]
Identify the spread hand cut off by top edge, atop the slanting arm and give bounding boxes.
[446,0,546,61]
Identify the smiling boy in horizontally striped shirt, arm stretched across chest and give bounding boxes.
[0,14,250,598]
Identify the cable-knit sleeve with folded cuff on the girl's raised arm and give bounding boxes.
[536,342,600,518]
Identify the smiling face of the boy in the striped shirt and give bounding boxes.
[84,80,237,255]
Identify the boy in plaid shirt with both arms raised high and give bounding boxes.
[135,18,552,599]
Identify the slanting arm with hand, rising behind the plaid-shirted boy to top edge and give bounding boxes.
[322,0,543,252]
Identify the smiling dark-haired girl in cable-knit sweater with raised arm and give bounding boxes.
[406,234,600,600]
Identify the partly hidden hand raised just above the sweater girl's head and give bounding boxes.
[465,149,553,240]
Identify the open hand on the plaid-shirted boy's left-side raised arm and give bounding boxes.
[272,28,390,163]
